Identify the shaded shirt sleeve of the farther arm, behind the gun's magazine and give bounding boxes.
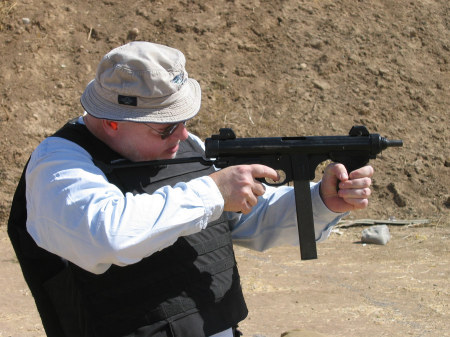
[229,183,346,251]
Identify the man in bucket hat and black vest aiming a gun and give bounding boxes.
[8,42,373,337]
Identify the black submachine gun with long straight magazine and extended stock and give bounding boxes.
[100,126,403,260]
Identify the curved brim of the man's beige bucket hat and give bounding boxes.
[81,78,201,123]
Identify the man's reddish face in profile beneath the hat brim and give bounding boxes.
[114,122,188,161]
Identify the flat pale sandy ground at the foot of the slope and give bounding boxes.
[0,223,450,337]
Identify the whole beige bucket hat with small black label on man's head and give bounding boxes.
[81,41,201,123]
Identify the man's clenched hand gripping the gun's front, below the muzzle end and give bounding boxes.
[320,163,373,213]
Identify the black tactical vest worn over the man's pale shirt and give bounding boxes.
[8,123,247,337]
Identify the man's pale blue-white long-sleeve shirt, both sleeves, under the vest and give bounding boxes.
[26,117,342,274]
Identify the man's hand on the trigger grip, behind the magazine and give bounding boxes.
[210,164,279,214]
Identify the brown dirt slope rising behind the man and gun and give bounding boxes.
[0,0,450,223]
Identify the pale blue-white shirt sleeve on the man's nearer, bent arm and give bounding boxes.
[26,137,223,274]
